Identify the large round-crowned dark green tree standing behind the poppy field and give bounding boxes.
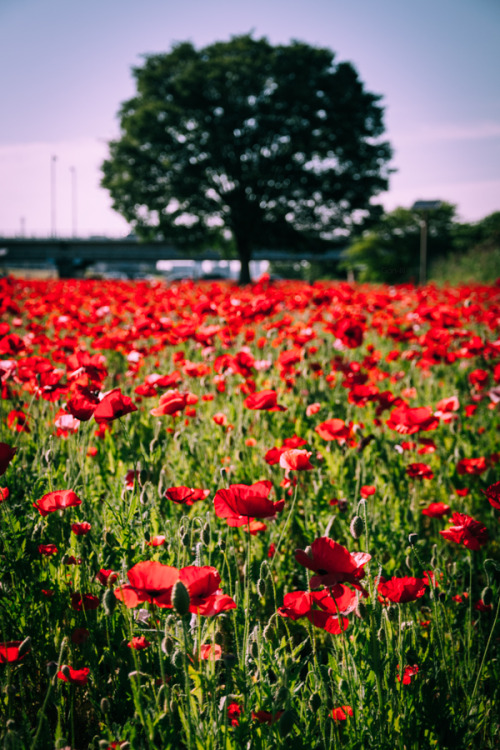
[102,35,391,283]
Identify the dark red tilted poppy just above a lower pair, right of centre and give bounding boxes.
[295,537,371,591]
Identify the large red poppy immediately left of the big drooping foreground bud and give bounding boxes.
[115,560,179,607]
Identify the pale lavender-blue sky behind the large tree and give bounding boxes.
[0,0,500,235]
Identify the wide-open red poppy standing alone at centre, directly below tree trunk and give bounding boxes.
[214,480,285,526]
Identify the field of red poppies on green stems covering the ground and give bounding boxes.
[0,277,500,750]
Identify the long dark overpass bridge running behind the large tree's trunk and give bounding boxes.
[0,237,342,278]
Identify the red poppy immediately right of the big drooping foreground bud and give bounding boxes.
[179,565,236,617]
